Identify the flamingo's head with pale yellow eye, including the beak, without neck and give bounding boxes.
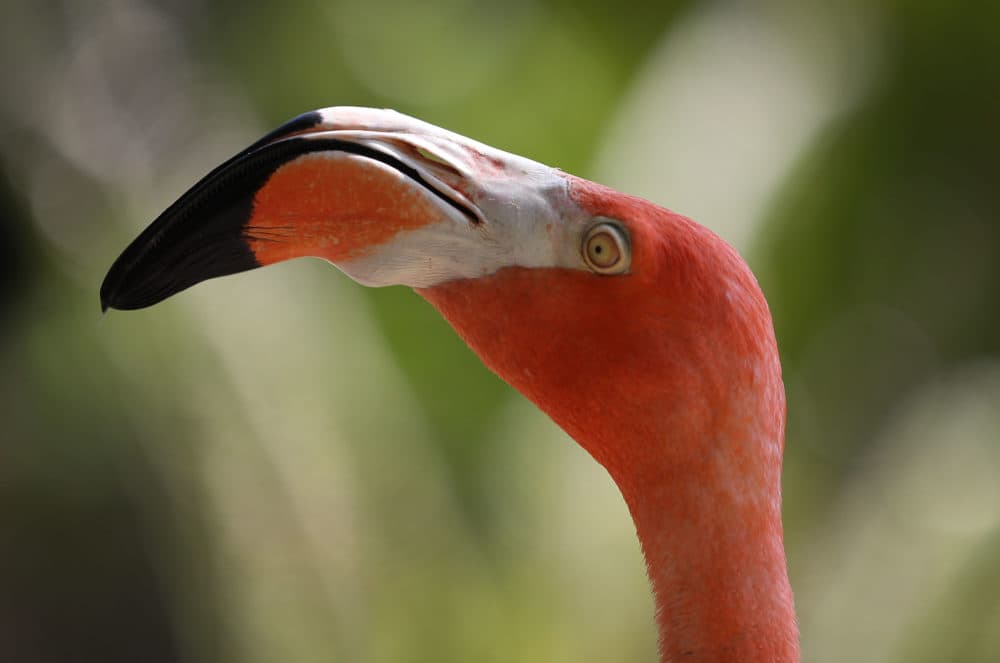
[101,107,770,482]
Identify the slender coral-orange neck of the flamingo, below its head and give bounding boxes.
[560,335,800,663]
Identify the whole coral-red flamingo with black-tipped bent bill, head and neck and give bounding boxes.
[100,107,799,663]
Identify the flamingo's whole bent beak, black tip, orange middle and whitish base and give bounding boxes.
[100,107,582,310]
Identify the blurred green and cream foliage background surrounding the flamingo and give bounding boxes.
[0,0,1000,663]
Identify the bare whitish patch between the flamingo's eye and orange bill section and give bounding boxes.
[304,108,589,288]
